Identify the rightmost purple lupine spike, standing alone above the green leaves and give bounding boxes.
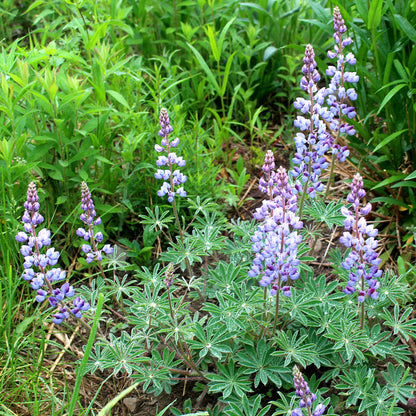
[340,173,383,303]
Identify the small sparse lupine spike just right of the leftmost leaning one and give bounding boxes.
[76,182,114,263]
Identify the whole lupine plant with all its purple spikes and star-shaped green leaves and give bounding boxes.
[8,4,416,416]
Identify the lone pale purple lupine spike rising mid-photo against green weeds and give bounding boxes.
[155,108,187,202]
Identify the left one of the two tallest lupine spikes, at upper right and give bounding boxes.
[290,45,331,206]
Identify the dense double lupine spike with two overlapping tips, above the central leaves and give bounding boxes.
[248,151,303,297]
